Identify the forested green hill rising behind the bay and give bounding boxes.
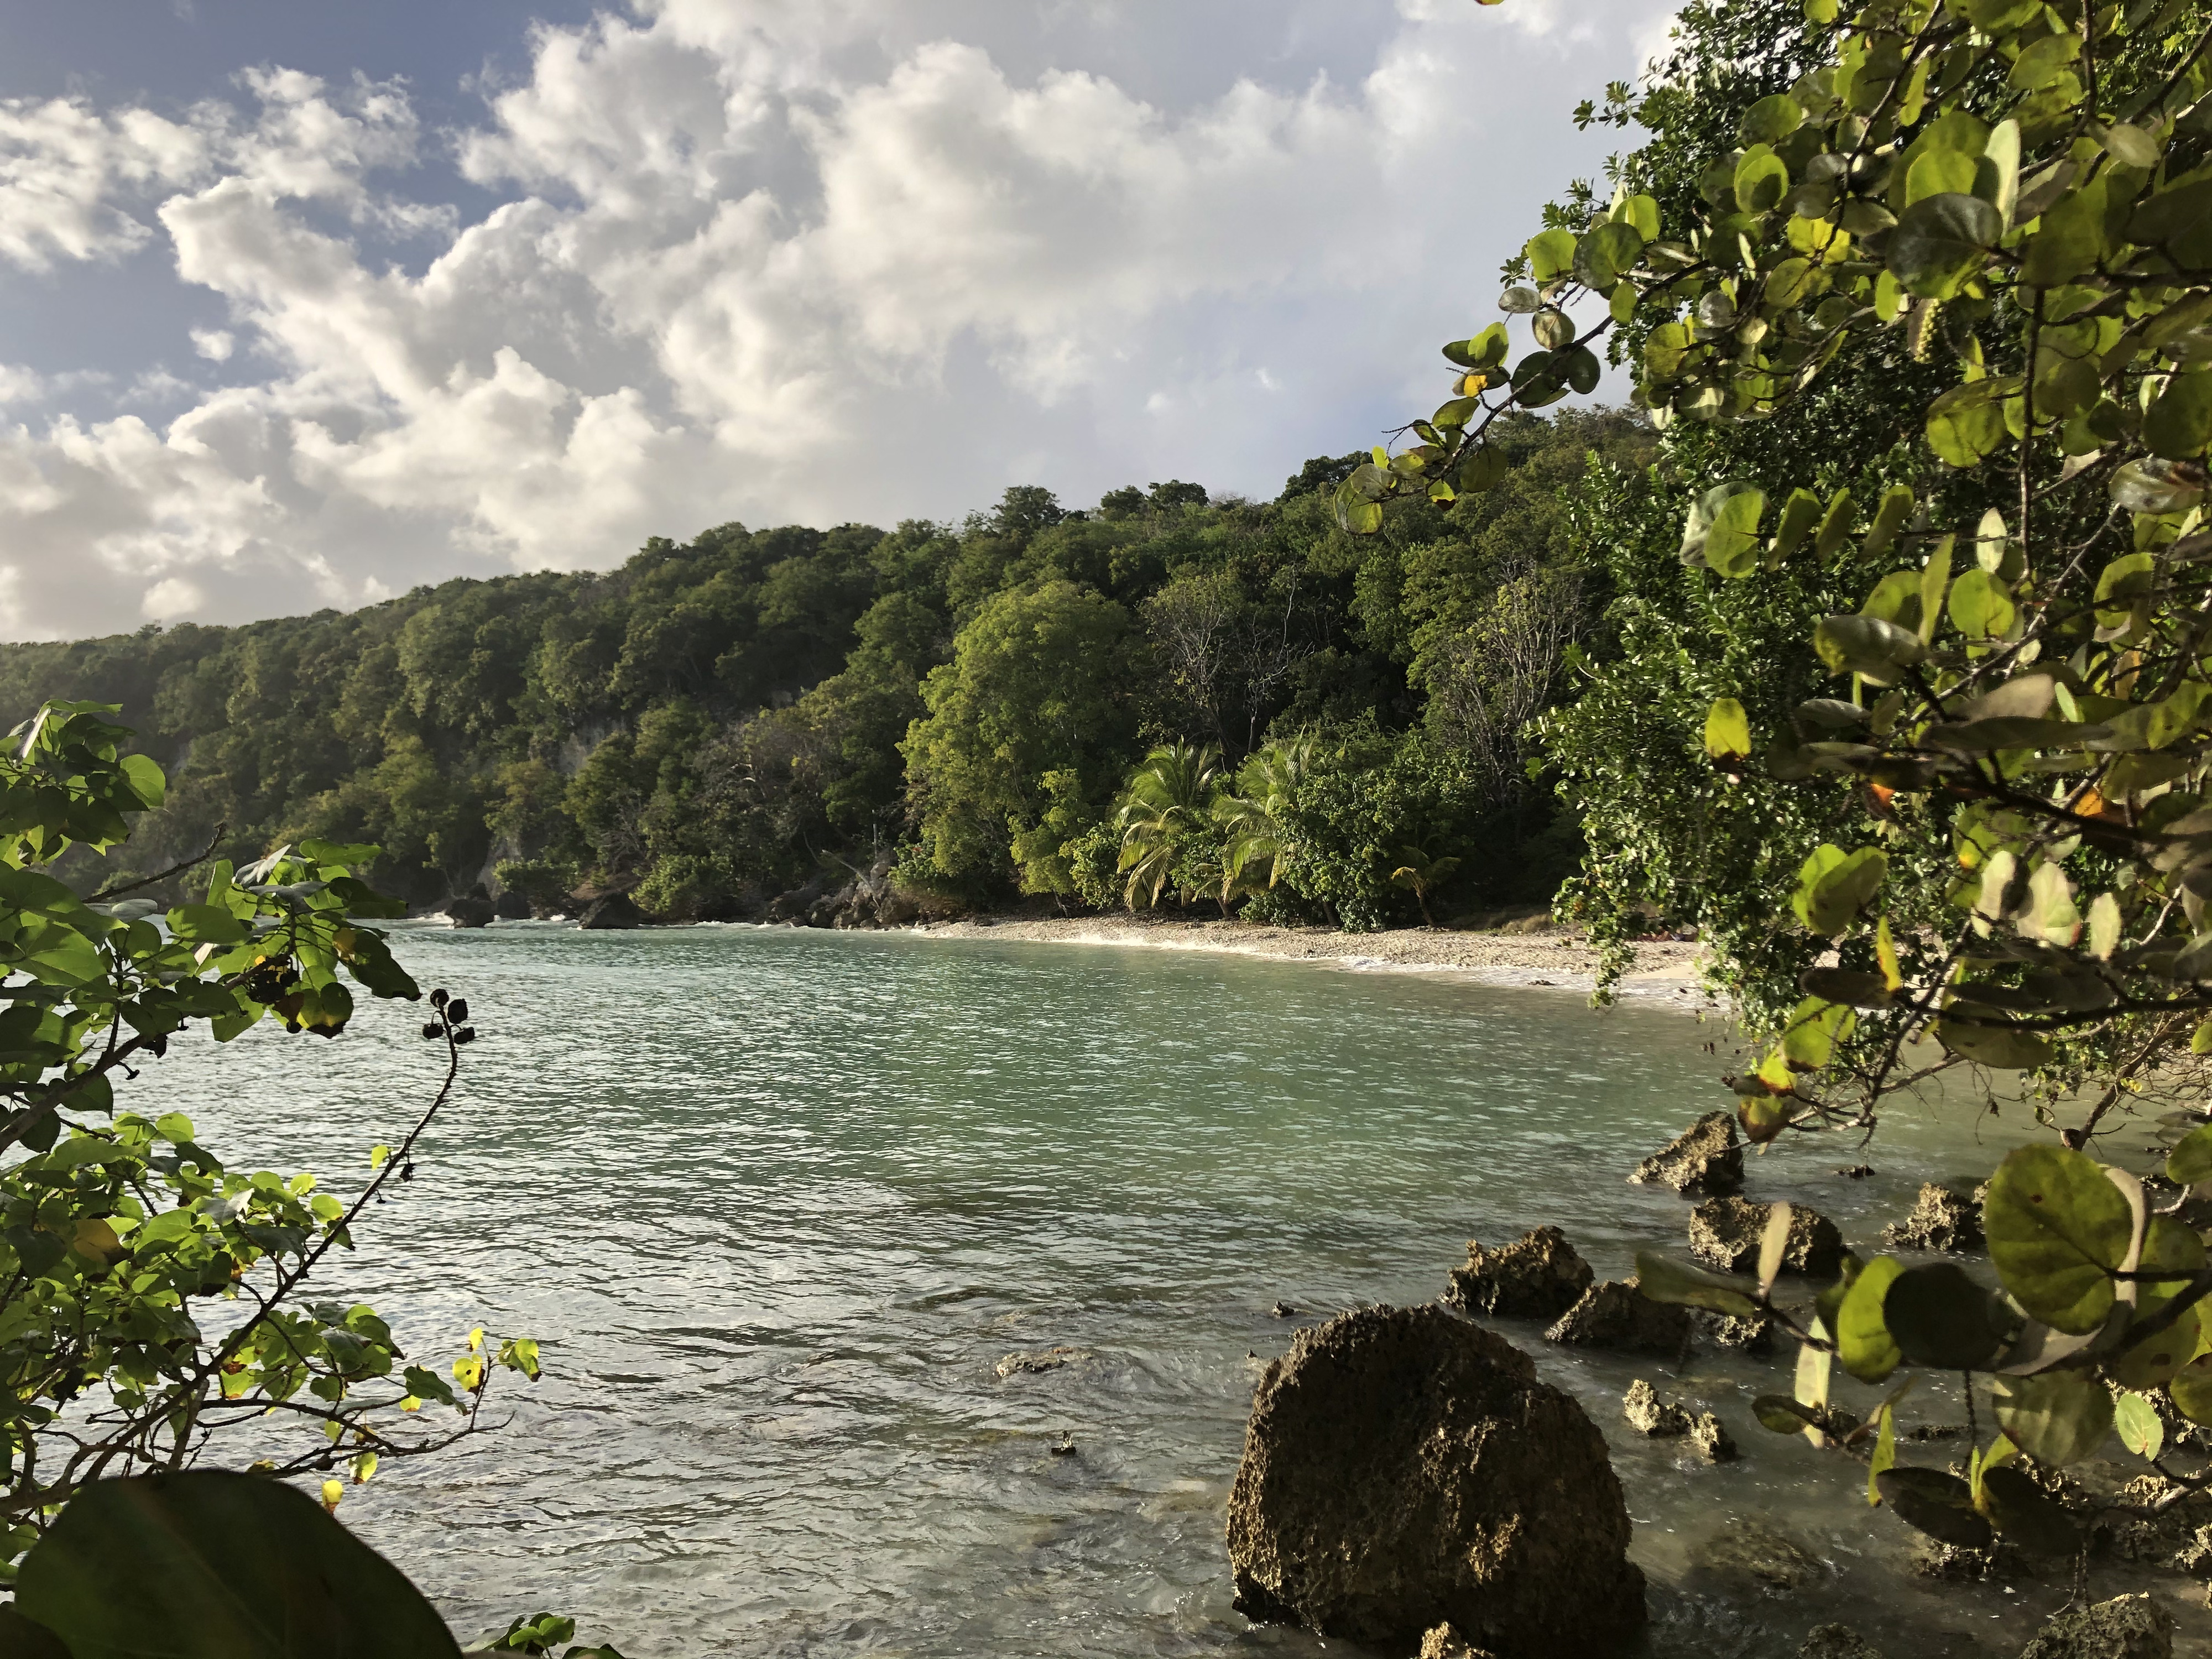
[13,414,1648,925]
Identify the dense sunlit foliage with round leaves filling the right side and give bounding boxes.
[1336,0,2212,1555]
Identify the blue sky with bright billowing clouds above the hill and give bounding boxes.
[0,0,1670,639]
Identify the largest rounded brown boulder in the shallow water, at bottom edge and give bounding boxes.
[1230,1305,1644,1659]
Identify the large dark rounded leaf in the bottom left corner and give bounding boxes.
[15,1471,460,1659]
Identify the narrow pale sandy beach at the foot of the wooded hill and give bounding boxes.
[909,916,1725,1013]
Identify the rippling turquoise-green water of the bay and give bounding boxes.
[159,925,2177,1659]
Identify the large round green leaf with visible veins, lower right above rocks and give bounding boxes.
[1982,1146,2135,1336]
